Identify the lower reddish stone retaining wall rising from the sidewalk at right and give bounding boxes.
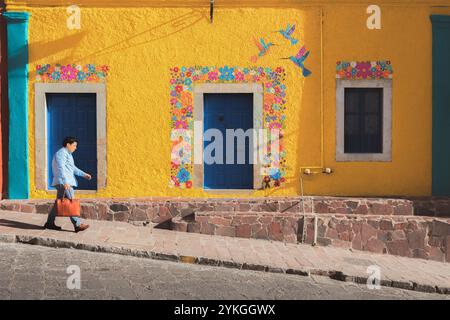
[170,211,450,262]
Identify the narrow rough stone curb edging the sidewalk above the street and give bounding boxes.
[0,234,450,294]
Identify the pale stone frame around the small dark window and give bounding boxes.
[336,79,392,162]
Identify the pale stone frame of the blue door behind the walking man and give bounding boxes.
[34,83,106,193]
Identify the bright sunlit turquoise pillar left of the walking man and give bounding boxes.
[3,12,30,199]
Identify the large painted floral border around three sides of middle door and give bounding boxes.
[169,66,286,189]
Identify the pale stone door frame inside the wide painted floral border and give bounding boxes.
[193,83,263,193]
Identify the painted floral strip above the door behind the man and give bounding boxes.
[36,64,109,82]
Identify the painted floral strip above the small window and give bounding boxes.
[336,60,394,80]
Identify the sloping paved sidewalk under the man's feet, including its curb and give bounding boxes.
[0,211,450,294]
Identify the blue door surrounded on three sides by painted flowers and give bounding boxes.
[203,93,253,189]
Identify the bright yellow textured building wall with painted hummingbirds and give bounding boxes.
[8,1,450,198]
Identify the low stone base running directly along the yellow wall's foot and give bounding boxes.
[0,197,414,223]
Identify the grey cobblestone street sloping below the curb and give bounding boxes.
[0,244,450,299]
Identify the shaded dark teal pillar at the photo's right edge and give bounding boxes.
[431,15,450,196]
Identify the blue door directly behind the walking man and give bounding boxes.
[46,93,97,190]
